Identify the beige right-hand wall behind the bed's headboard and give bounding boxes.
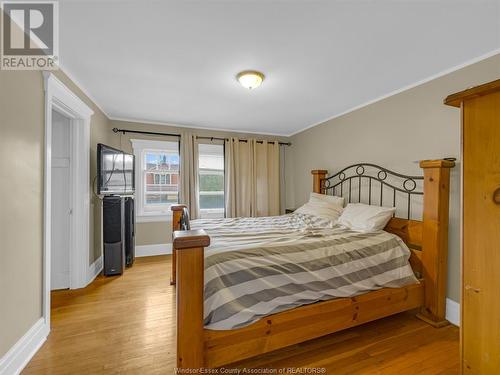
[287,55,500,301]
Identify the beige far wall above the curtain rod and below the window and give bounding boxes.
[108,120,289,246]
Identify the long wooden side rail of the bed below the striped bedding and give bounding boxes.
[204,284,424,367]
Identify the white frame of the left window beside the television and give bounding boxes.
[130,138,182,223]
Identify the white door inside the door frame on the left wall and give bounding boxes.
[51,111,71,290]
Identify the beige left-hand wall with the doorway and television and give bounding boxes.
[0,71,109,357]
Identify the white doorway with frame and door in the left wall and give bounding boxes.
[42,72,94,328]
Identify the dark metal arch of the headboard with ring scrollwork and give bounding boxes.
[321,163,424,220]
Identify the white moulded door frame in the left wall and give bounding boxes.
[42,72,94,327]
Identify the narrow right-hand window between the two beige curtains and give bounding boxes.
[198,144,224,218]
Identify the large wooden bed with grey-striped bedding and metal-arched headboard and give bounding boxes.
[172,160,454,369]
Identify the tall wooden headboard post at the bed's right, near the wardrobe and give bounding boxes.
[417,160,455,327]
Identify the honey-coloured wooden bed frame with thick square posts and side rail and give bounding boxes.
[172,160,455,369]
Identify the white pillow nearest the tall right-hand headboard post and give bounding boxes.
[338,203,396,232]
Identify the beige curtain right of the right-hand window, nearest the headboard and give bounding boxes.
[225,138,280,217]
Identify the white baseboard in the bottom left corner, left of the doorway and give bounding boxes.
[0,318,49,375]
